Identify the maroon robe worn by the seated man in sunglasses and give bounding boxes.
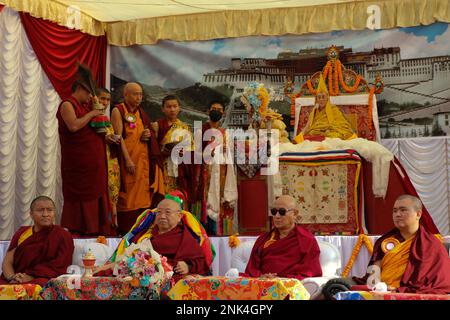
[244,226,322,280]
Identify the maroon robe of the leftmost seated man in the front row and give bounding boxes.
[0,226,74,286]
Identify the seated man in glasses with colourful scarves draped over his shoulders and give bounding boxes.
[97,191,213,281]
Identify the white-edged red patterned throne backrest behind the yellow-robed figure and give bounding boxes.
[294,94,380,141]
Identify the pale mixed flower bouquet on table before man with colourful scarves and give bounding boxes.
[114,239,173,288]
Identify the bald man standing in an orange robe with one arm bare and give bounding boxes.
[111,82,164,234]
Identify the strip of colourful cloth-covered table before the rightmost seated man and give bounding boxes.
[334,291,450,300]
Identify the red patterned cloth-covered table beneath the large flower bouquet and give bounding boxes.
[41,276,159,300]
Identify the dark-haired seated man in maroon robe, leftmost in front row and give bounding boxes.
[0,196,74,286]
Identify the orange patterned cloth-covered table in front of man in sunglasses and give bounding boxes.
[168,276,309,300]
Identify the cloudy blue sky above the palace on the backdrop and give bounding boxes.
[111,23,450,88]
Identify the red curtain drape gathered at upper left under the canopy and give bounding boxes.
[20,12,107,99]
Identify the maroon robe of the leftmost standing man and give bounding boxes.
[57,96,111,235]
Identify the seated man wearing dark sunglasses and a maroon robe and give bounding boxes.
[244,195,322,280]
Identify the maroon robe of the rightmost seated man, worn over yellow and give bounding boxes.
[353,224,450,294]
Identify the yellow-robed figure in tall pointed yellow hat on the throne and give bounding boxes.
[294,74,357,143]
